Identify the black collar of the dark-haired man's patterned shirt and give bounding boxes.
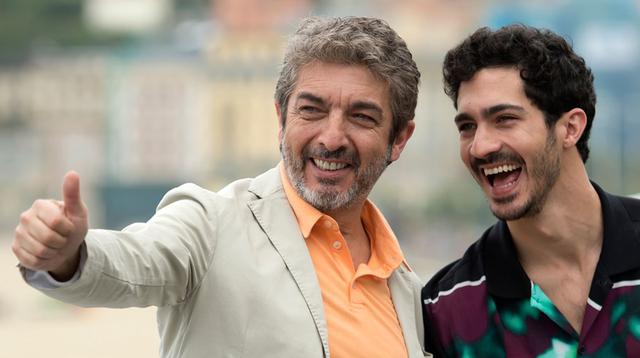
[481,182,640,298]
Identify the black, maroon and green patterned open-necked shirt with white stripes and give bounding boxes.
[422,184,640,358]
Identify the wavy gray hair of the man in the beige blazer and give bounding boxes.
[275,17,420,143]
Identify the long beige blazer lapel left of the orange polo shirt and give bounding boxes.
[249,168,329,357]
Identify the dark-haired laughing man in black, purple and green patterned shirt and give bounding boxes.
[422,25,640,357]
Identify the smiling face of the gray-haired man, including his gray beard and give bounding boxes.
[278,62,413,212]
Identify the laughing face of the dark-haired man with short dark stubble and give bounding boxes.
[455,67,562,220]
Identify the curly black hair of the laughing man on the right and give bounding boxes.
[442,24,596,162]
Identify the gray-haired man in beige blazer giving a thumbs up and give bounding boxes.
[13,17,423,357]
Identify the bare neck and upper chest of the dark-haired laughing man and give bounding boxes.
[507,167,603,333]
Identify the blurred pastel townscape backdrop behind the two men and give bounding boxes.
[0,0,640,274]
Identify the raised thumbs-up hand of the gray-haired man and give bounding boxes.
[12,171,88,281]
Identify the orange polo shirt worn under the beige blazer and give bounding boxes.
[280,163,407,358]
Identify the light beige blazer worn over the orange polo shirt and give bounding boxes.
[32,168,424,358]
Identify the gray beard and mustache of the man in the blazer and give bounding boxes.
[280,138,391,213]
